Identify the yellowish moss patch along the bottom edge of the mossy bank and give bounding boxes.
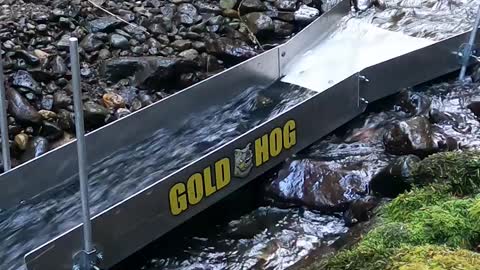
[385,245,480,270]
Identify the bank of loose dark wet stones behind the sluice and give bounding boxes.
[0,0,321,170]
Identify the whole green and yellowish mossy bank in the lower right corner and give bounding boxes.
[306,151,480,270]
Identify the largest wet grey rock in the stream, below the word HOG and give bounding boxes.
[267,159,366,212]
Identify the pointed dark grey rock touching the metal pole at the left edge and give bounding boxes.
[6,88,42,124]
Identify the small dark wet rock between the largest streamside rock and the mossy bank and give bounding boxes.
[343,196,379,227]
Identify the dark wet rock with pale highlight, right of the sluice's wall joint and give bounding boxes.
[383,116,436,157]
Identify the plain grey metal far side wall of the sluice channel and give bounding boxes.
[0,48,279,209]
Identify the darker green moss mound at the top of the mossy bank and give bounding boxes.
[412,151,480,196]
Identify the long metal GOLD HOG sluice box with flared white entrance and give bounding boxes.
[0,0,478,270]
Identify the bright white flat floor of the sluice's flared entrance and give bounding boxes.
[282,20,434,92]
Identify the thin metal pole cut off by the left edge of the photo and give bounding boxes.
[0,46,12,172]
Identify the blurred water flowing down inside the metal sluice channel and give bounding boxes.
[0,82,313,270]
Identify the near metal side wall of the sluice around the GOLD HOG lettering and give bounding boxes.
[25,75,362,270]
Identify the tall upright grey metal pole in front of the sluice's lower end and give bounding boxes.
[70,37,95,254]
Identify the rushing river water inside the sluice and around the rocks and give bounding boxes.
[0,1,479,270]
